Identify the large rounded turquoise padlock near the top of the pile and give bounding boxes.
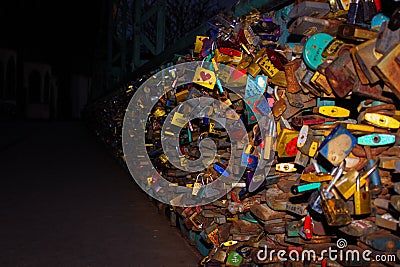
[303,32,334,70]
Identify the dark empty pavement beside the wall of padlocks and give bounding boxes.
[0,121,200,267]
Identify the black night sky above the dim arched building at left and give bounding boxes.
[0,0,102,75]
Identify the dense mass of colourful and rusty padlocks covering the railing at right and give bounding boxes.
[86,0,400,266]
